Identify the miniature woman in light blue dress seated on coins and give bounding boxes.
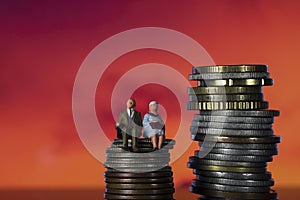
[143,101,165,151]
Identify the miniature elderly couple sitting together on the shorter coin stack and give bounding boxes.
[115,98,165,152]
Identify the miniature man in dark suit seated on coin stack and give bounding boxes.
[116,98,143,152]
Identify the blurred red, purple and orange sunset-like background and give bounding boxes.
[0,0,300,199]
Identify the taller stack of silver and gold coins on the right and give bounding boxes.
[187,65,280,200]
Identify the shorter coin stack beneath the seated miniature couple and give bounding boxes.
[104,139,175,200]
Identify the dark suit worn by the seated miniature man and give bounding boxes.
[118,109,143,148]
